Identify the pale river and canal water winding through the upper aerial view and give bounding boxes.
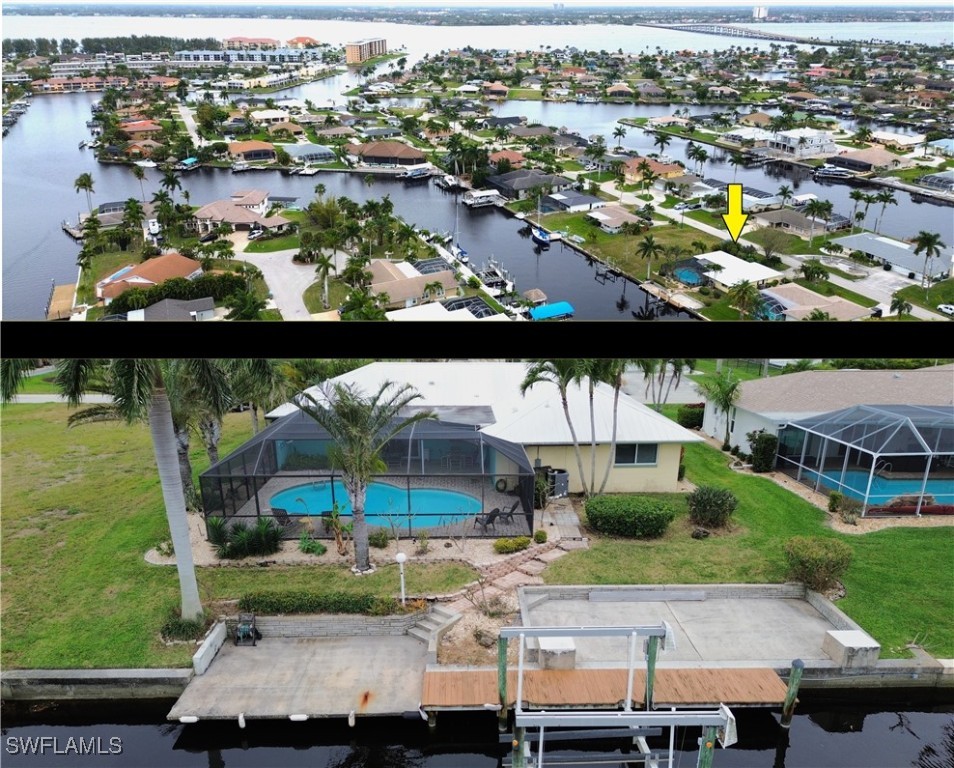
[2,16,954,320]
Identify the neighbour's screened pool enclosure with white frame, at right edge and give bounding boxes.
[777,405,954,515]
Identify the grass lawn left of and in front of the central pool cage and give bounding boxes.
[0,404,473,669]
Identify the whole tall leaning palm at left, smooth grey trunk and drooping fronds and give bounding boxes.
[0,358,230,621]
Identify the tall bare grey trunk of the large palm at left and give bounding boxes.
[149,388,204,621]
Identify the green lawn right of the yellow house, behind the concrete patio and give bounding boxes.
[543,445,954,658]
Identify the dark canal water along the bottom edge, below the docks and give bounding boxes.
[2,691,954,768]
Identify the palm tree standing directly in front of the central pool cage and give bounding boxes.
[299,381,434,573]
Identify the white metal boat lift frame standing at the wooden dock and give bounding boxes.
[497,622,738,768]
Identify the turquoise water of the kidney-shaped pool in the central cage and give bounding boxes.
[269,480,483,528]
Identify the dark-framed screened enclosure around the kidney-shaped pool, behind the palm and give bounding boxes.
[200,409,534,538]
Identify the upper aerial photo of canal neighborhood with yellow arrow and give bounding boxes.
[2,1,954,323]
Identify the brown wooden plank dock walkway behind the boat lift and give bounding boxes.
[421,668,787,711]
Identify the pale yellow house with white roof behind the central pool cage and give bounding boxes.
[268,362,701,493]
